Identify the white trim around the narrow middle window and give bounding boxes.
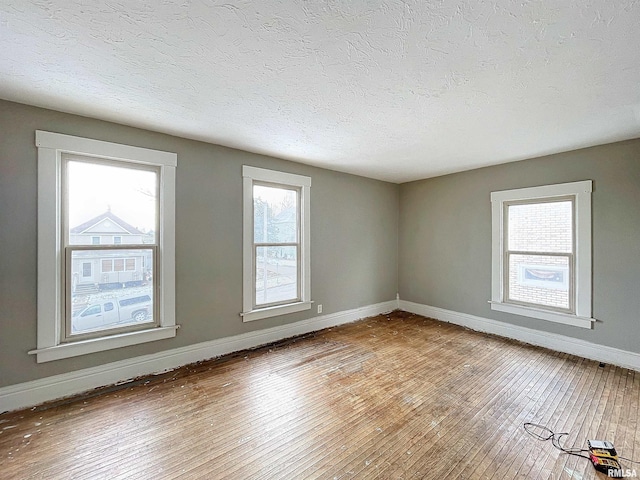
[240,165,312,322]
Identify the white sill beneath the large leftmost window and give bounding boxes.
[29,325,179,363]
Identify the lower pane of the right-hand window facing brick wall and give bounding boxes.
[508,254,571,309]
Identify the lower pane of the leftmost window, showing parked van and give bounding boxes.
[71,249,154,335]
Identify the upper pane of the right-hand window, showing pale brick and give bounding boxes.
[508,201,573,253]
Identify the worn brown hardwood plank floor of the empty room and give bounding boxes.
[0,312,640,480]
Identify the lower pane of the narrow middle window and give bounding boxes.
[255,247,299,305]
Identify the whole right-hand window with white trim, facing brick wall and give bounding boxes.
[491,180,594,328]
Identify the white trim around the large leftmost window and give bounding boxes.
[29,130,178,363]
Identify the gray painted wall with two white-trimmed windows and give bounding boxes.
[0,101,399,386]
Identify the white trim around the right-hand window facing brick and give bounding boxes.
[490,180,595,328]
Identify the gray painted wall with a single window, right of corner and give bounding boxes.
[399,140,640,352]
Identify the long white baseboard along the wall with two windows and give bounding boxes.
[0,300,398,413]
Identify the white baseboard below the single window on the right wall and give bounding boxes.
[398,300,640,371]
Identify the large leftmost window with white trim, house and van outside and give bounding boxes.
[29,131,177,362]
